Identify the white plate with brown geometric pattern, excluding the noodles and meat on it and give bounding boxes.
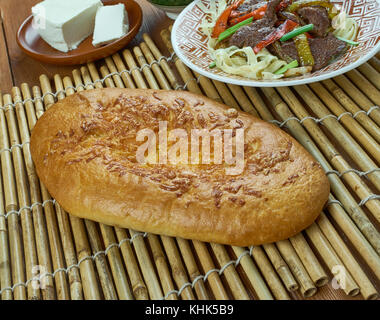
[172,0,380,87]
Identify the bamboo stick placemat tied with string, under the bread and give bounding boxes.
[0,30,380,299]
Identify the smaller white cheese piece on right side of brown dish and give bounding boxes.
[92,4,129,47]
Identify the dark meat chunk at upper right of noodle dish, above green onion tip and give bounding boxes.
[297,7,331,37]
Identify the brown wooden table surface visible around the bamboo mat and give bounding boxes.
[0,0,368,300]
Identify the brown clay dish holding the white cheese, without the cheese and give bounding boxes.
[17,0,142,65]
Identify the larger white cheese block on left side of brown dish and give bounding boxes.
[32,0,103,52]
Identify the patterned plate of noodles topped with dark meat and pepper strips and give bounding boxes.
[172,0,380,87]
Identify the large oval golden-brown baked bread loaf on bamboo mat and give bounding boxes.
[30,89,330,246]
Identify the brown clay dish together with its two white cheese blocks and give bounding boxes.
[17,0,142,65]
